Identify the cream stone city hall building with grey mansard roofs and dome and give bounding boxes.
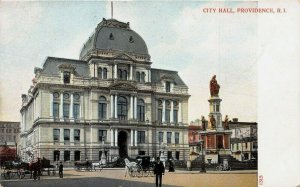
[19,19,190,164]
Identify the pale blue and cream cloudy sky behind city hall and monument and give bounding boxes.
[0,1,258,122]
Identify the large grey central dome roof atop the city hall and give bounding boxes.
[80,18,150,59]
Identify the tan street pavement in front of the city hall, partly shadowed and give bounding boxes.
[0,169,257,187]
